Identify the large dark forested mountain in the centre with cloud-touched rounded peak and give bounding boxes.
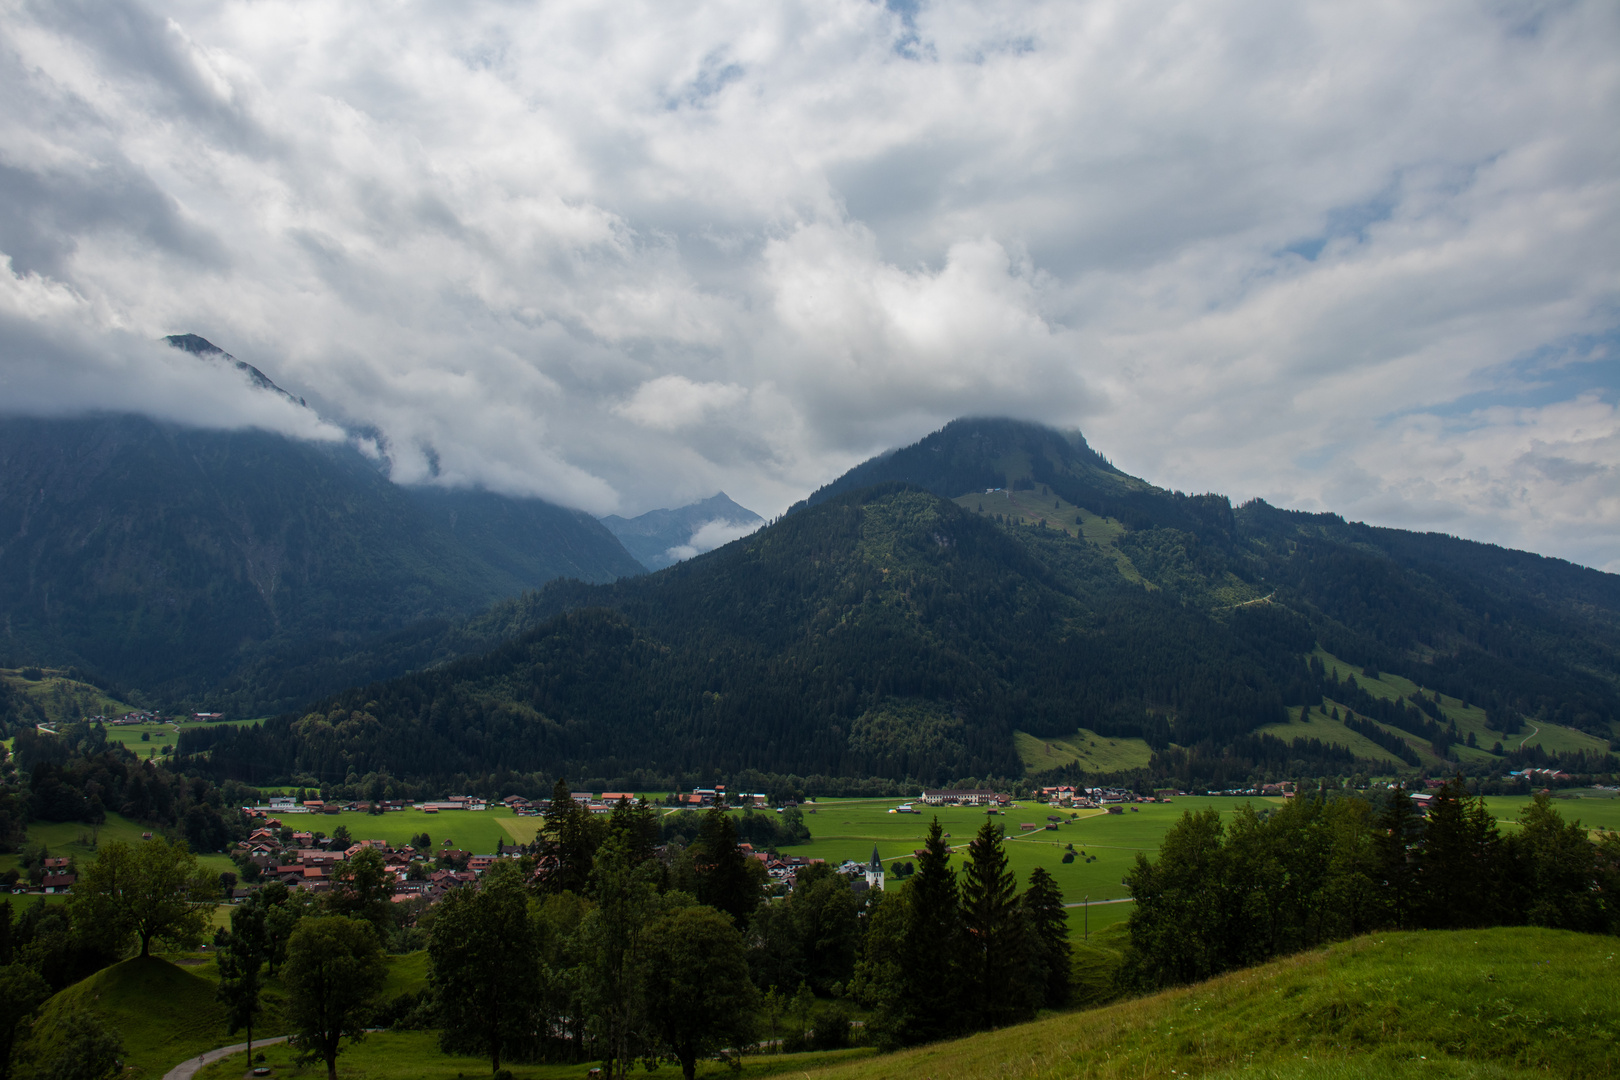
[183,421,1620,782]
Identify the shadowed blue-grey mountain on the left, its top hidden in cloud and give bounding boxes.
[0,416,642,714]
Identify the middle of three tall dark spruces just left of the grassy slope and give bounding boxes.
[962,818,1029,1028]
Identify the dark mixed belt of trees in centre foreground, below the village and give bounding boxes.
[208,785,1069,1080]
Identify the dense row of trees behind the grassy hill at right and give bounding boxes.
[1121,780,1620,988]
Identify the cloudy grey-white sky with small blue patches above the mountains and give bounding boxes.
[0,0,1620,570]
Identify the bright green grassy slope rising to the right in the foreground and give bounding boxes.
[812,928,1620,1080]
